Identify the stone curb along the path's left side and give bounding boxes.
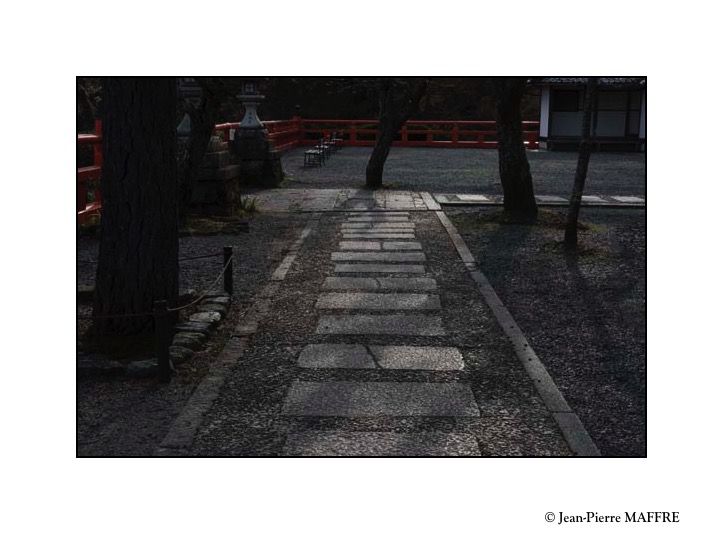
[154,212,320,457]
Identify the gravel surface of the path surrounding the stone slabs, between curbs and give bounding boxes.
[192,212,568,455]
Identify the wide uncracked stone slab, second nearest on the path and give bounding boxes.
[282,381,480,418]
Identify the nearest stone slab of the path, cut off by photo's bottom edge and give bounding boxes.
[283,430,480,457]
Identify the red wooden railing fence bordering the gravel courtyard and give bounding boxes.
[77,117,540,223]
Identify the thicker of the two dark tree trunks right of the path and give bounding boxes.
[495,77,537,220]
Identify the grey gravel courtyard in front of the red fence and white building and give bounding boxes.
[282,147,645,196]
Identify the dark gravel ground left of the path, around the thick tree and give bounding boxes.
[77,213,307,456]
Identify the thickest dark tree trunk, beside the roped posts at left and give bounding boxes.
[93,77,178,336]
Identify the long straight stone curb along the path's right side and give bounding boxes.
[435,210,601,456]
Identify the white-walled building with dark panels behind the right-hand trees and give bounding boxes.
[533,77,646,151]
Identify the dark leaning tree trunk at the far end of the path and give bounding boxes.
[365,78,428,189]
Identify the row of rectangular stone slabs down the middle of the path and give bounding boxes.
[282,212,480,455]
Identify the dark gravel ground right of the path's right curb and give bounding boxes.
[447,207,647,456]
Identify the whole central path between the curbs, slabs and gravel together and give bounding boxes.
[184,202,572,456]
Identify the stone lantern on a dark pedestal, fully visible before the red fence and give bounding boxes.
[233,79,283,187]
